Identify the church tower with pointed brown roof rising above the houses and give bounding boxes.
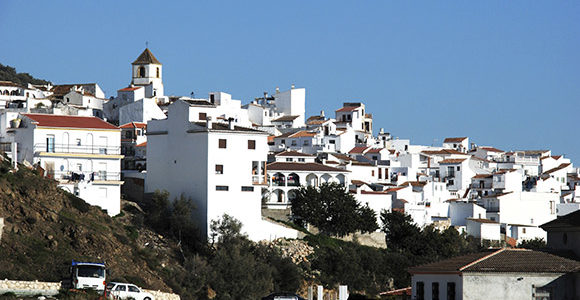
[131,48,163,98]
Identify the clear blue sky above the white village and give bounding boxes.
[0,0,580,163]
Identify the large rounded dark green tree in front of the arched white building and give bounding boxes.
[292,183,379,237]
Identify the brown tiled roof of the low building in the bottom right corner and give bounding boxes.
[409,248,580,274]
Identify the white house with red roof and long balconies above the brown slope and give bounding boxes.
[8,114,123,216]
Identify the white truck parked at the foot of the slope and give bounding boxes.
[71,260,107,291]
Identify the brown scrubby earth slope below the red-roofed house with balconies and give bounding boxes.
[0,158,182,291]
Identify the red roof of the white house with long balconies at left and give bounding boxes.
[24,114,119,129]
